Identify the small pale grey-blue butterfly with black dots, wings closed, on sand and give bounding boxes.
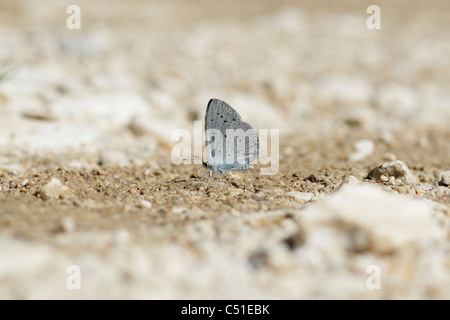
[203,99,259,184]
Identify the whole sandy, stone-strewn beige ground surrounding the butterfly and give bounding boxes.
[0,0,450,299]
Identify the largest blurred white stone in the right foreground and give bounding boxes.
[301,185,445,252]
